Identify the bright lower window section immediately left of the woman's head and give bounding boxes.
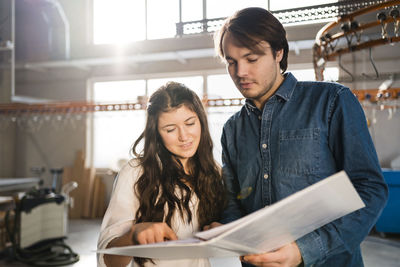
[92,80,146,169]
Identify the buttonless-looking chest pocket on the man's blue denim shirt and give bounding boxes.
[279,128,320,175]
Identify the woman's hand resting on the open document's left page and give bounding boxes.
[132,222,178,244]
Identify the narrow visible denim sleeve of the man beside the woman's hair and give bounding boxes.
[220,126,243,223]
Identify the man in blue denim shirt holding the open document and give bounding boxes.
[215,8,387,267]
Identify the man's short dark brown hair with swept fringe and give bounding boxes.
[214,7,289,73]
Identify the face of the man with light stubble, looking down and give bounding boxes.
[222,33,283,109]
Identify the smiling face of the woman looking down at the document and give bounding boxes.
[157,105,201,167]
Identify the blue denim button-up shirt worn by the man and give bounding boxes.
[221,73,387,267]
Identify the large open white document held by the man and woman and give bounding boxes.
[97,171,365,259]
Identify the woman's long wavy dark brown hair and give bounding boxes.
[132,82,225,265]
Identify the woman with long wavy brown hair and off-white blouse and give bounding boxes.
[98,82,225,267]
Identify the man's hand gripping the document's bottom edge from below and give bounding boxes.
[240,242,303,267]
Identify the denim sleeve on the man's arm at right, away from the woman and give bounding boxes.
[296,87,388,266]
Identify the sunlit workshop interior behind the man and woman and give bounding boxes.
[0,0,400,267]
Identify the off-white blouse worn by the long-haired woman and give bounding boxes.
[97,160,210,267]
